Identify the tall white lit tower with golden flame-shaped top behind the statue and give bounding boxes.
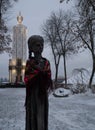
[9,13,27,83]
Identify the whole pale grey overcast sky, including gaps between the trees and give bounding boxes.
[0,0,91,77]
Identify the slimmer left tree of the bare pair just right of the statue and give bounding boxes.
[42,18,61,87]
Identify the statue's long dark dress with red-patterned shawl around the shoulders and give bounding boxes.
[24,58,52,130]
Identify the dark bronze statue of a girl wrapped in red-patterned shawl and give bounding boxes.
[24,35,52,130]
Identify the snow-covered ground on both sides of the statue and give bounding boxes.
[0,88,95,130]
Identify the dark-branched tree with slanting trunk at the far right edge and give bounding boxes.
[61,0,95,87]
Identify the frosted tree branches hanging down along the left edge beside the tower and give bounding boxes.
[0,0,18,53]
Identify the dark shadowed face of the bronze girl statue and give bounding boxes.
[31,42,43,54]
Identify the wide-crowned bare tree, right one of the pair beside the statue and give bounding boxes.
[41,10,75,86]
